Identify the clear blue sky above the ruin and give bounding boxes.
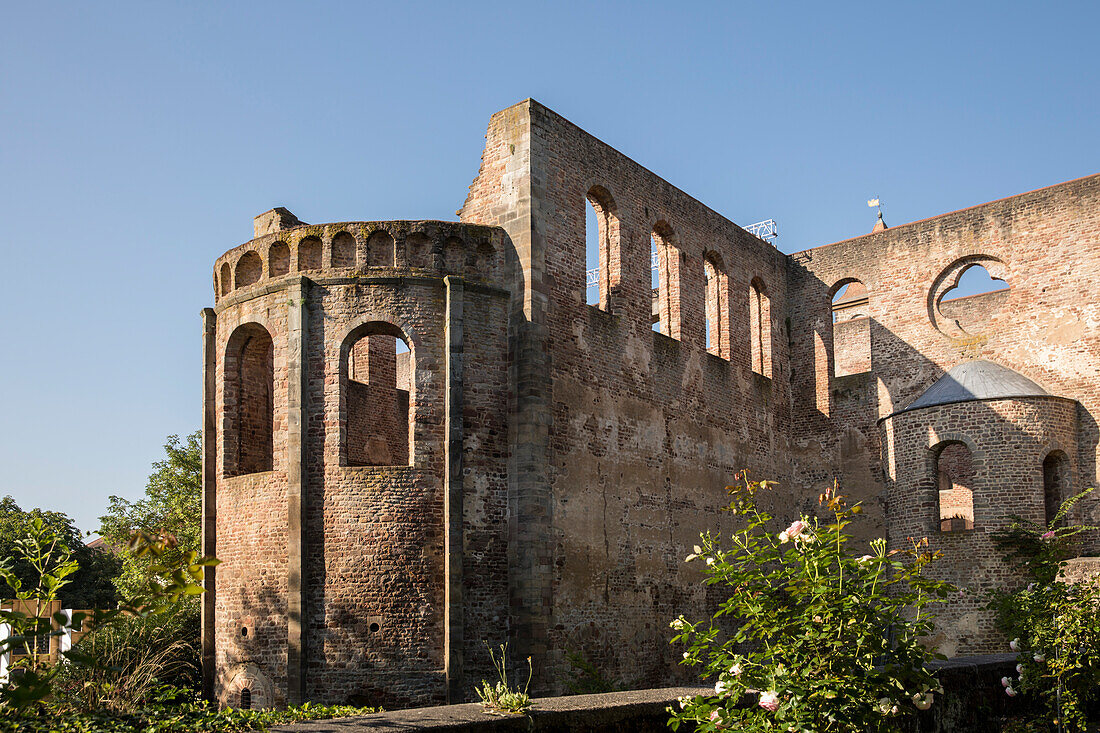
[0,1,1100,529]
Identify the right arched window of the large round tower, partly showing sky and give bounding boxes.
[342,322,415,466]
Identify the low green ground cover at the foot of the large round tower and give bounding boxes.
[0,686,380,733]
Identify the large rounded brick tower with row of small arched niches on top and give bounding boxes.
[202,209,509,707]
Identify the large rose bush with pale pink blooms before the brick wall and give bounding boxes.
[669,472,953,733]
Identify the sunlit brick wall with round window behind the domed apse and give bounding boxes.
[789,176,1100,548]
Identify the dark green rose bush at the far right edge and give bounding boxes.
[990,489,1100,731]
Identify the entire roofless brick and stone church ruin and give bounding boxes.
[202,100,1100,707]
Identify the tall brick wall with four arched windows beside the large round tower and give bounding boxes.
[461,101,791,690]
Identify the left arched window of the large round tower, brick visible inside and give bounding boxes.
[222,324,275,477]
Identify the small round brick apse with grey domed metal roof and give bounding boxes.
[880,360,1078,656]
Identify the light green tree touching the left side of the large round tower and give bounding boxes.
[99,431,202,593]
